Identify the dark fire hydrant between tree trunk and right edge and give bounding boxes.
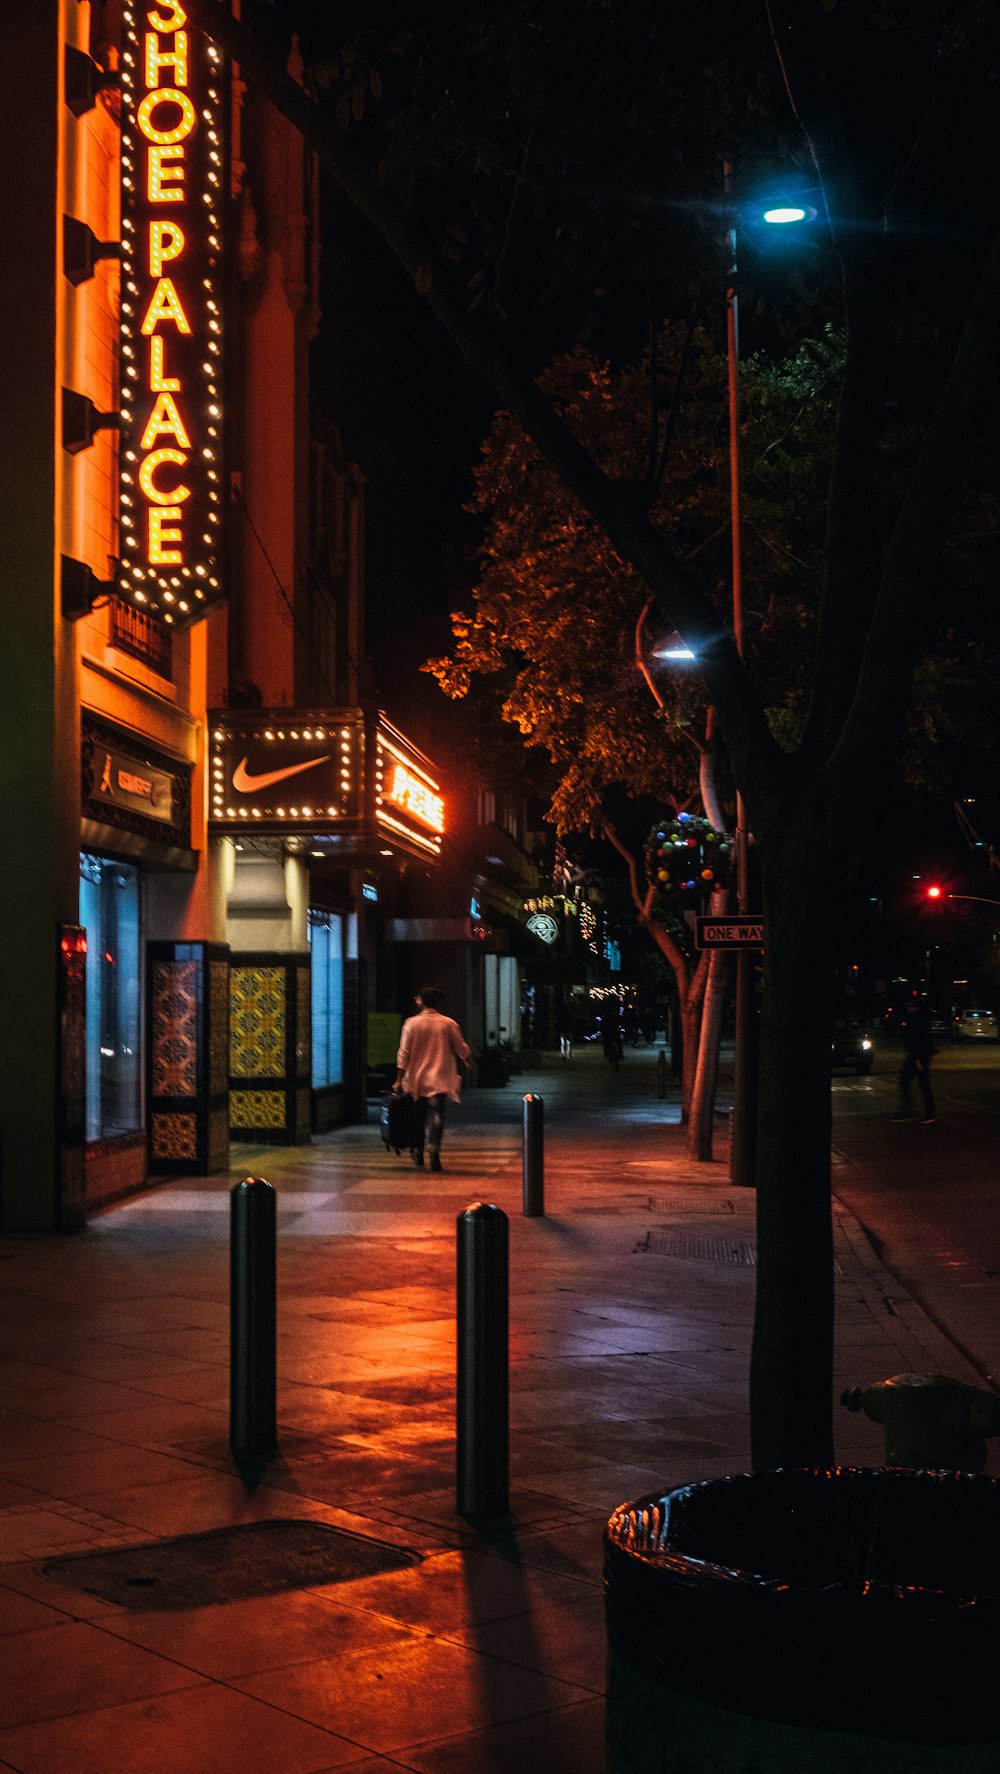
[840,1373,1000,1472]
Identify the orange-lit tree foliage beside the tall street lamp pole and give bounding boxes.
[424,323,842,830]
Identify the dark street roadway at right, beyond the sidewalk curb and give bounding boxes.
[833,1036,1000,1377]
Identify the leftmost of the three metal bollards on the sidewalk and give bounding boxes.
[229,1176,277,1453]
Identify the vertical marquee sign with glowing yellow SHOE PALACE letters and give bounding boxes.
[117,0,225,624]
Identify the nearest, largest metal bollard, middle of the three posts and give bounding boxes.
[456,1201,509,1517]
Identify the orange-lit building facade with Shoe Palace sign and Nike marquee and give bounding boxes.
[0,0,445,1231]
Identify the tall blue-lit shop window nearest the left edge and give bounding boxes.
[80,855,142,1139]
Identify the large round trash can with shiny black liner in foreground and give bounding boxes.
[605,1467,1000,1774]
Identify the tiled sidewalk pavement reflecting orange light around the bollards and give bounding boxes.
[0,1050,979,1774]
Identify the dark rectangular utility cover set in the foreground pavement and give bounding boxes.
[43,1520,418,1611]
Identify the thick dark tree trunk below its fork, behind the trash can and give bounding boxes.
[750,805,835,1467]
